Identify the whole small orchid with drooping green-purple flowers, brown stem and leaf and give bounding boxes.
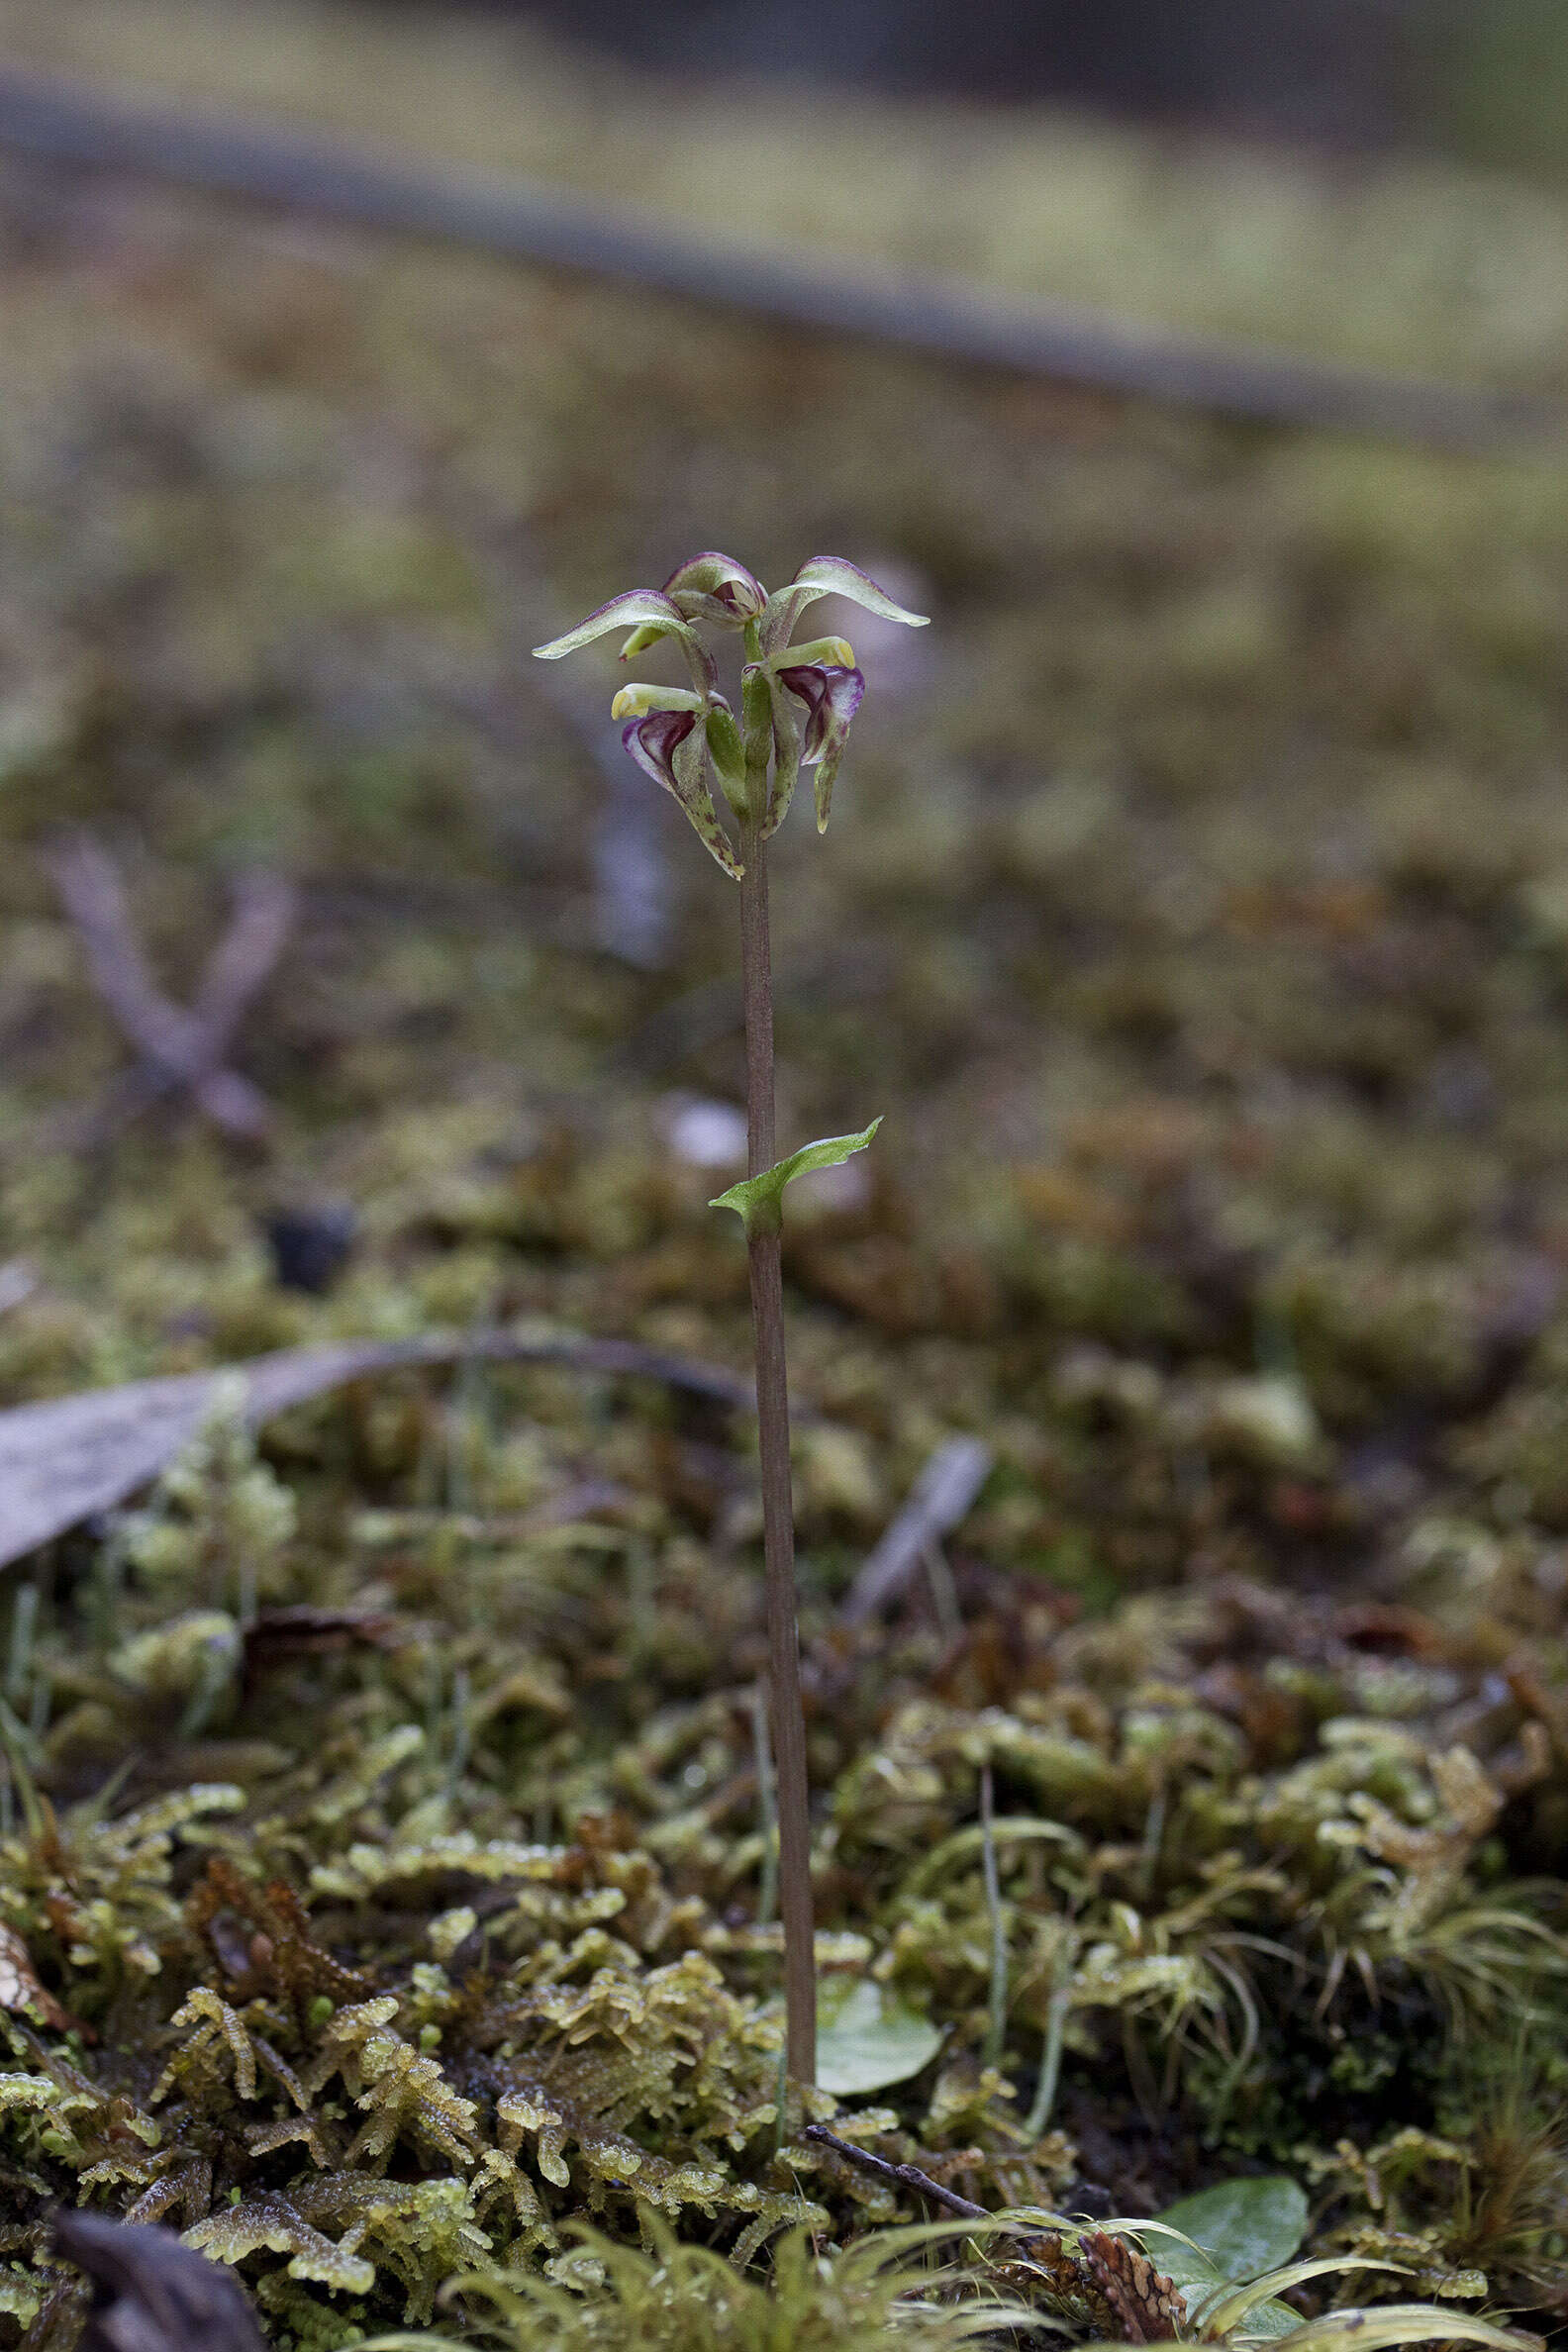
[534,550,927,2084]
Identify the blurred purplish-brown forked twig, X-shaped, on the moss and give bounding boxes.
[45,833,294,1147]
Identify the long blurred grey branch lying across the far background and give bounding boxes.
[0,66,1568,449]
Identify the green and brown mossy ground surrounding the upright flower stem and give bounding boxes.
[0,10,1568,2345]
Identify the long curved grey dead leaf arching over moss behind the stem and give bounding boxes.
[0,1331,770,1569]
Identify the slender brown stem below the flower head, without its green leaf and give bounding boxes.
[740,819,816,2084]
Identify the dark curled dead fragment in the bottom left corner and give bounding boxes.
[51,2206,263,2352]
